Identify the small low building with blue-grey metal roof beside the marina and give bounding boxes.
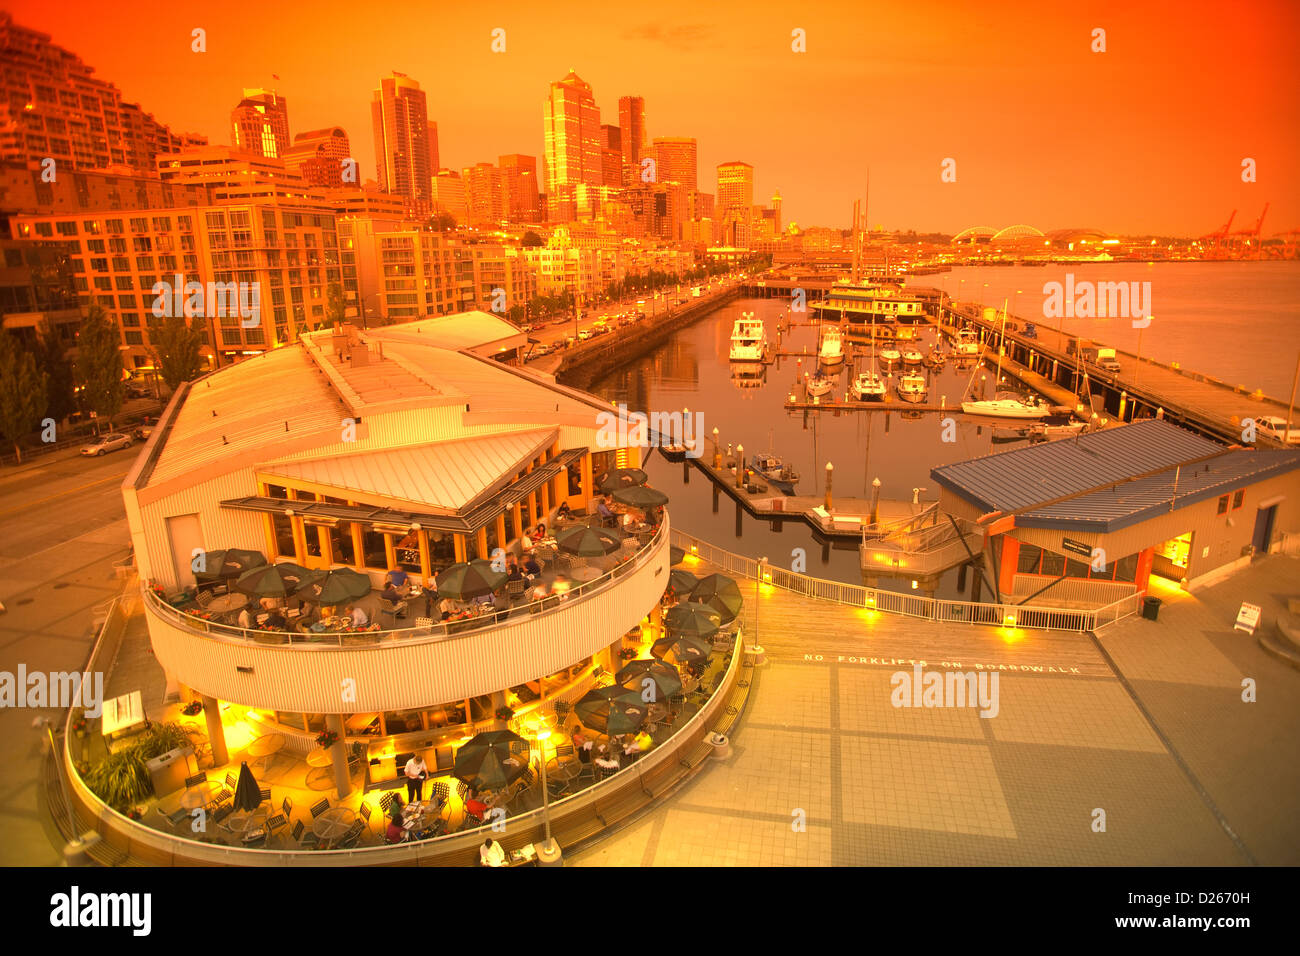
[931,420,1300,602]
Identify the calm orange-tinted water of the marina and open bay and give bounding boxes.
[592,263,1300,597]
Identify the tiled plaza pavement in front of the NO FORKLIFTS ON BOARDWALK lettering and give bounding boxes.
[567,557,1300,866]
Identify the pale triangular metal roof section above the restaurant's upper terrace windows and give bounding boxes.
[259,428,559,511]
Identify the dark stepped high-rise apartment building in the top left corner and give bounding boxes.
[0,10,208,173]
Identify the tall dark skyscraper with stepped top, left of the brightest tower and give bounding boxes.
[371,73,433,216]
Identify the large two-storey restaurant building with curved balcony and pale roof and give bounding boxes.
[124,315,670,797]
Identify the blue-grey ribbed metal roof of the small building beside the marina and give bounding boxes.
[930,420,1300,532]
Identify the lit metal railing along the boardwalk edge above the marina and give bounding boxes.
[672,531,1140,631]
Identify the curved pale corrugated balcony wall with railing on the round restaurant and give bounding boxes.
[143,518,670,714]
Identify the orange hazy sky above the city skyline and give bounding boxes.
[5,0,1300,235]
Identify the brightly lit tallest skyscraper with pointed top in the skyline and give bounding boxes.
[542,70,605,219]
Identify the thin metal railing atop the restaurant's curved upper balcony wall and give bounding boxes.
[140,518,668,650]
